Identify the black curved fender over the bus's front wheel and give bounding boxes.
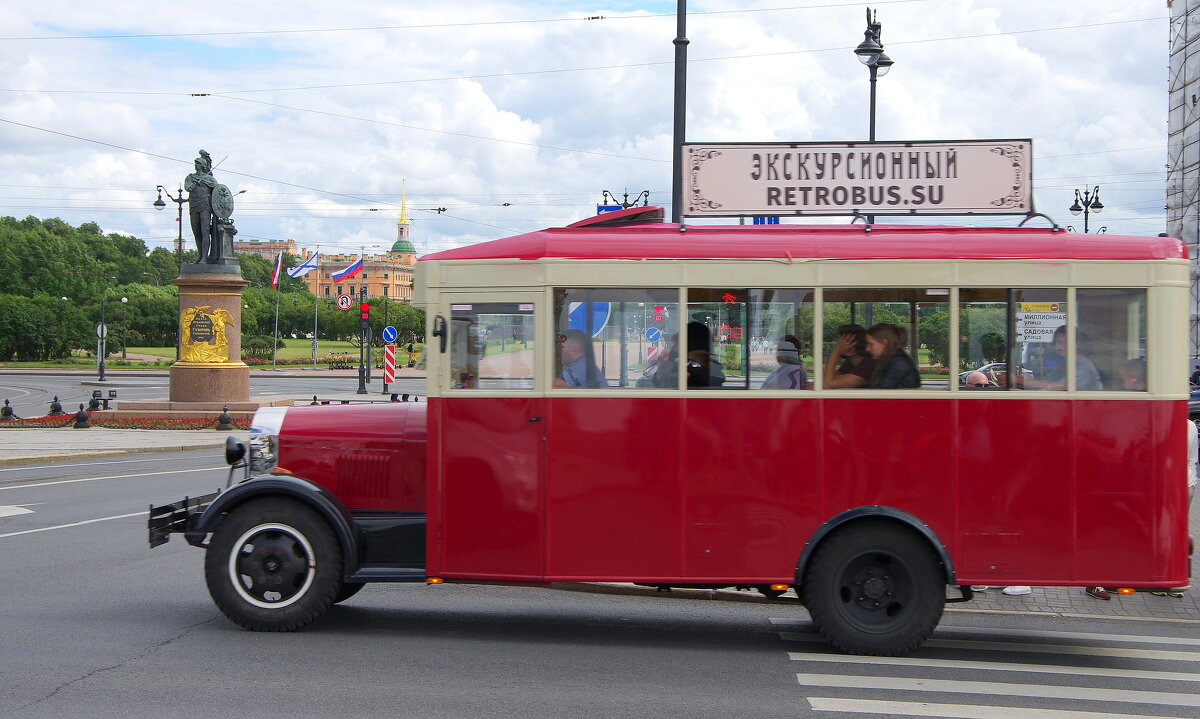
[184,474,361,576]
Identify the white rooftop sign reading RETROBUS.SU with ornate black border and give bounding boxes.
[683,139,1033,217]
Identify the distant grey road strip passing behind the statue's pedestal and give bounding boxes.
[0,370,425,417]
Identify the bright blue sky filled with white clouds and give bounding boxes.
[0,0,1169,259]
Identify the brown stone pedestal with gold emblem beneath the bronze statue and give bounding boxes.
[170,260,250,405]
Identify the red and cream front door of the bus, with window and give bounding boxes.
[428,293,546,580]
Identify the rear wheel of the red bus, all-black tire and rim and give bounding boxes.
[802,521,946,657]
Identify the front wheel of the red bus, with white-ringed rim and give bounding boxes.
[204,498,343,631]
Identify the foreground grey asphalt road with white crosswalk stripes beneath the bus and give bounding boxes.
[0,450,1200,719]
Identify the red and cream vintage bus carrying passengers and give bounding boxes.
[150,208,1190,654]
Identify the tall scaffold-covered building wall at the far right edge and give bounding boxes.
[1166,0,1200,356]
